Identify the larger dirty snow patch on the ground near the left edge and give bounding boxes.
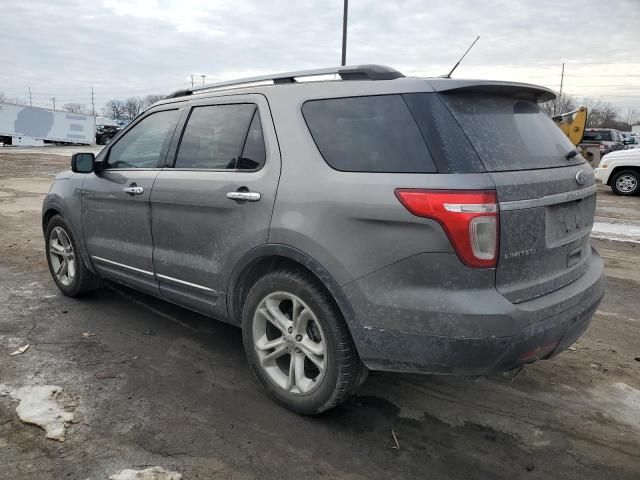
[0,385,73,442]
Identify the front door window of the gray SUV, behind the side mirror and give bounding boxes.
[106,110,179,168]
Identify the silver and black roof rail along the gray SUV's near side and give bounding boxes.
[165,65,404,99]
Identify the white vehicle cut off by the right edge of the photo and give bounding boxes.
[594,148,640,195]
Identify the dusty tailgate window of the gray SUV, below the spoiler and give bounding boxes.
[441,92,583,171]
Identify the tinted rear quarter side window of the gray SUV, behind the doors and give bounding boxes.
[302,95,437,173]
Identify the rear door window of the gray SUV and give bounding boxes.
[175,103,264,170]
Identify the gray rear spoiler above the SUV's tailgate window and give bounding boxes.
[427,78,556,103]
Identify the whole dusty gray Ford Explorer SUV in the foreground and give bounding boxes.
[42,65,605,414]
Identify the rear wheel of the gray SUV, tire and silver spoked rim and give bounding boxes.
[242,270,367,415]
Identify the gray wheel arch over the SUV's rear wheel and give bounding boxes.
[227,244,359,326]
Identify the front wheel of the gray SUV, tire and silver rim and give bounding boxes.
[44,215,100,297]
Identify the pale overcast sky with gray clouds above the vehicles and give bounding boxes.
[0,0,640,115]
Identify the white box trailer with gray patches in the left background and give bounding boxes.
[0,103,96,145]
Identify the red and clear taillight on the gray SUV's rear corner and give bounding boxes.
[396,188,499,268]
